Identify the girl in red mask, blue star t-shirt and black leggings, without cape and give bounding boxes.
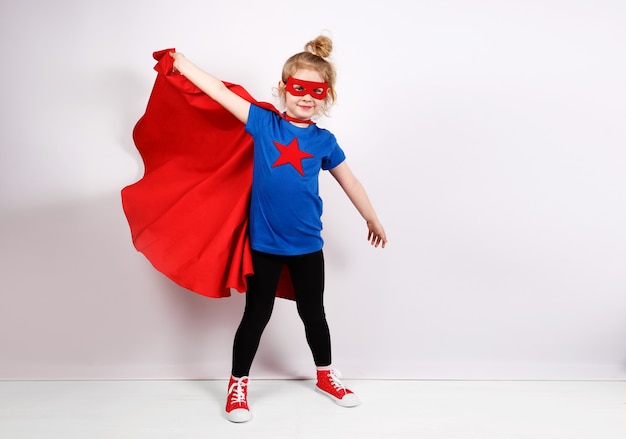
[171,36,387,422]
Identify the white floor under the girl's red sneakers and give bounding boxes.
[0,380,626,439]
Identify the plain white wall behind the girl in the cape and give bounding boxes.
[0,0,626,379]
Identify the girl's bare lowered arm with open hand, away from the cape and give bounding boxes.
[330,160,387,248]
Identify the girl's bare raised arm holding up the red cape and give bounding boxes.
[170,52,250,124]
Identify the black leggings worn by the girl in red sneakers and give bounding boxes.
[232,250,331,377]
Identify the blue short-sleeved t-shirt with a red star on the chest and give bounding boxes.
[246,104,346,255]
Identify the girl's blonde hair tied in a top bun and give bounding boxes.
[278,35,337,115]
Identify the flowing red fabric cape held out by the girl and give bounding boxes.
[122,49,294,299]
